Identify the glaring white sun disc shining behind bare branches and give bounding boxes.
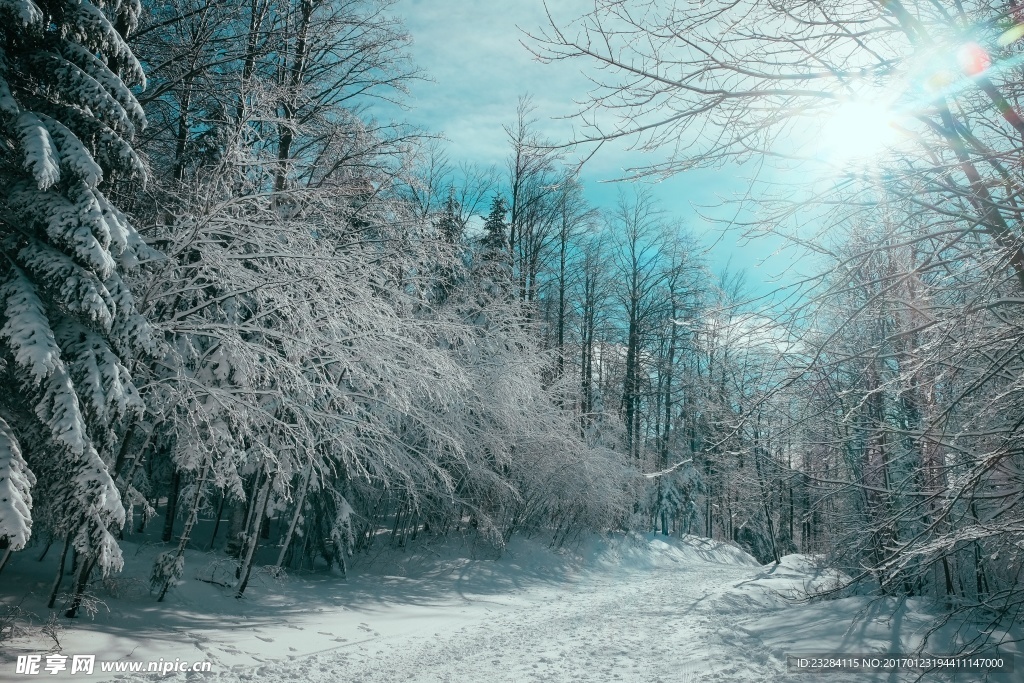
[818,100,899,167]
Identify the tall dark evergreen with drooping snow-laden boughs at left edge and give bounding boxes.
[0,0,152,616]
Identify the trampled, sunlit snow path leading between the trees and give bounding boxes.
[331,565,783,683]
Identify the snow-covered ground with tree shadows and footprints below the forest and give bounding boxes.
[0,537,1024,683]
